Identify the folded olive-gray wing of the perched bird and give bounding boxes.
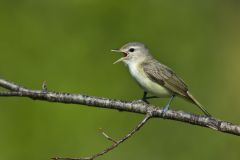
[143,61,188,98]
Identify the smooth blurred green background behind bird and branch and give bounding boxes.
[0,0,240,160]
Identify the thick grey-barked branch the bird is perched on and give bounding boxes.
[0,78,240,136]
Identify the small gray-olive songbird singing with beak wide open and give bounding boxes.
[112,42,211,116]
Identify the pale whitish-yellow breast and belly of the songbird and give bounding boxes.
[128,64,171,97]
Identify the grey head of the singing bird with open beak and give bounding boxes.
[112,42,151,65]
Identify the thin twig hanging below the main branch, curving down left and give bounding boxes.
[53,112,152,160]
